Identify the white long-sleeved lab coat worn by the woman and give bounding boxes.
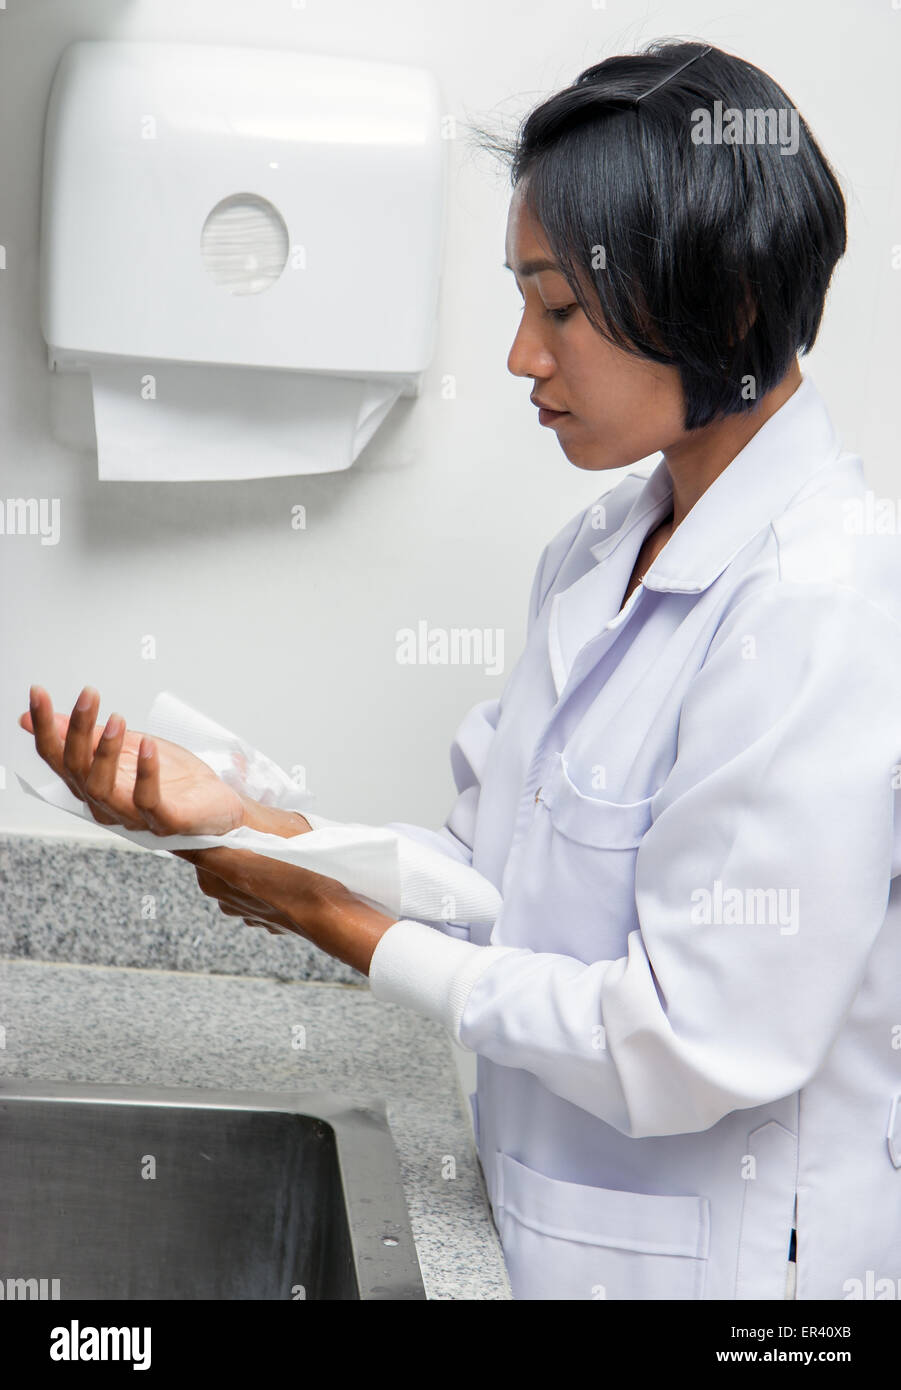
[370,377,901,1300]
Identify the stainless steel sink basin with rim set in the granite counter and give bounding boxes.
[0,1079,425,1300]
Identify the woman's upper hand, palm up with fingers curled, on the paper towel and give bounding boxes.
[19,685,251,835]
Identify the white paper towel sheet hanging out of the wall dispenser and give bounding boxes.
[90,359,402,482]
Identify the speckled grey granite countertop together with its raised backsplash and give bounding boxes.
[0,837,512,1300]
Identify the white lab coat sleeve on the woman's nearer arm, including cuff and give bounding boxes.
[370,582,901,1138]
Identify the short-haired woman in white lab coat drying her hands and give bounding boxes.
[21,44,901,1300]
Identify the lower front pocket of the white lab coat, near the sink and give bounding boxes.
[495,1152,711,1300]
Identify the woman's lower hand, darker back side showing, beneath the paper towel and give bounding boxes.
[174,847,398,974]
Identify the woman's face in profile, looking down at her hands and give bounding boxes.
[506,182,685,470]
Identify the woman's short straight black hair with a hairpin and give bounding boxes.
[473,40,847,430]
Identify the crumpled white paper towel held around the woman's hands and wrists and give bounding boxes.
[17,691,502,924]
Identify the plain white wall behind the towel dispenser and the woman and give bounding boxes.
[0,0,901,1100]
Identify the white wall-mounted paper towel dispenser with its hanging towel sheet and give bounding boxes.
[40,40,445,481]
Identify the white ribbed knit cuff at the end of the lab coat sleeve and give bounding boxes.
[368,919,523,1052]
